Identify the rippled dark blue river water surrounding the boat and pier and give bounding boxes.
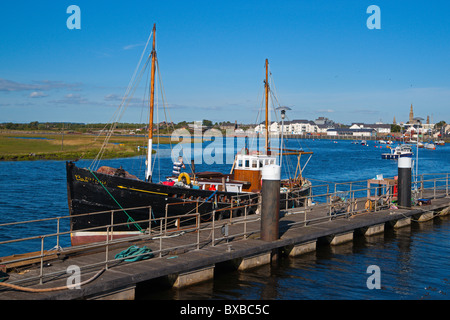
[0,140,450,300]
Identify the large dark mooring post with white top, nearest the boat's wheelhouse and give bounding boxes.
[261,165,281,241]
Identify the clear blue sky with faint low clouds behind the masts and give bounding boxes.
[0,0,450,124]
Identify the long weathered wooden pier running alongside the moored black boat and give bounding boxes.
[0,176,450,300]
